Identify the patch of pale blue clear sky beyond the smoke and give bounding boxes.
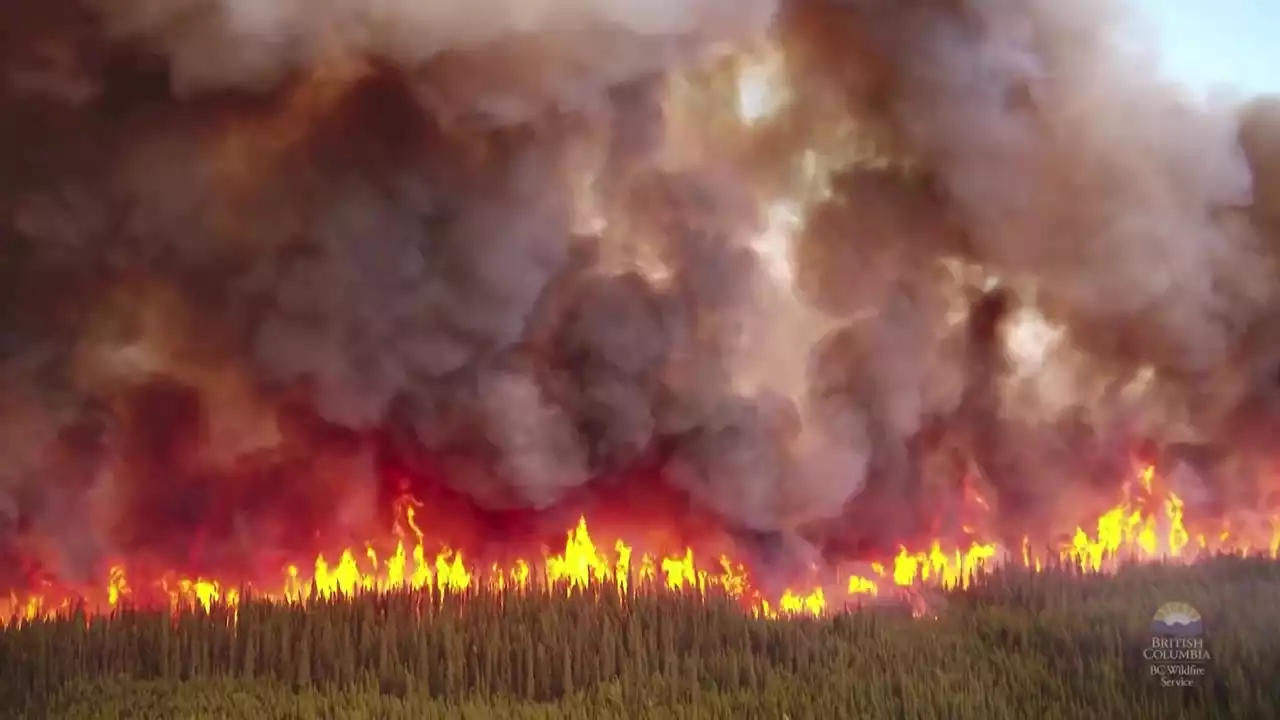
[1129,0,1280,95]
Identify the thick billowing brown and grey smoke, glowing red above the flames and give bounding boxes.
[0,0,1280,582]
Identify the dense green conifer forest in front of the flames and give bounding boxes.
[0,557,1280,720]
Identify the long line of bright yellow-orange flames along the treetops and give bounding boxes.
[10,458,1280,620]
